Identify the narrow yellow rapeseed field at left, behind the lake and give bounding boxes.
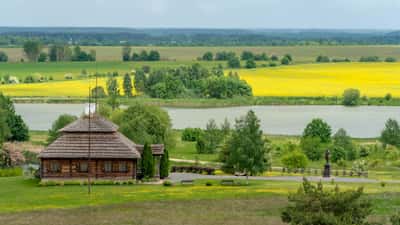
[0,78,130,97]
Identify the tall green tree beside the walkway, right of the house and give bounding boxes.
[223,110,270,181]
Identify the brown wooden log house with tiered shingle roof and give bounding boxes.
[39,115,164,180]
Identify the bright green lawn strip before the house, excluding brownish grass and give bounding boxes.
[0,177,400,214]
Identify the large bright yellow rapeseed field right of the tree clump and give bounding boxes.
[237,63,400,97]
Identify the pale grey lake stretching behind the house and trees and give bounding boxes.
[15,104,400,138]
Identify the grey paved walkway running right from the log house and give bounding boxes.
[169,173,400,183]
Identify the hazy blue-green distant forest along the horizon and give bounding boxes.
[0,27,400,47]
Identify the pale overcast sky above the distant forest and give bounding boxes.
[0,0,400,29]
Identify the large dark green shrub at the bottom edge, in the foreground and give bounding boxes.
[281,179,372,225]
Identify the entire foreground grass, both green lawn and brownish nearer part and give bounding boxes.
[0,177,400,224]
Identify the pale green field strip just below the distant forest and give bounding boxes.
[0,45,400,63]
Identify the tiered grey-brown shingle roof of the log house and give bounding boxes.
[39,116,164,159]
